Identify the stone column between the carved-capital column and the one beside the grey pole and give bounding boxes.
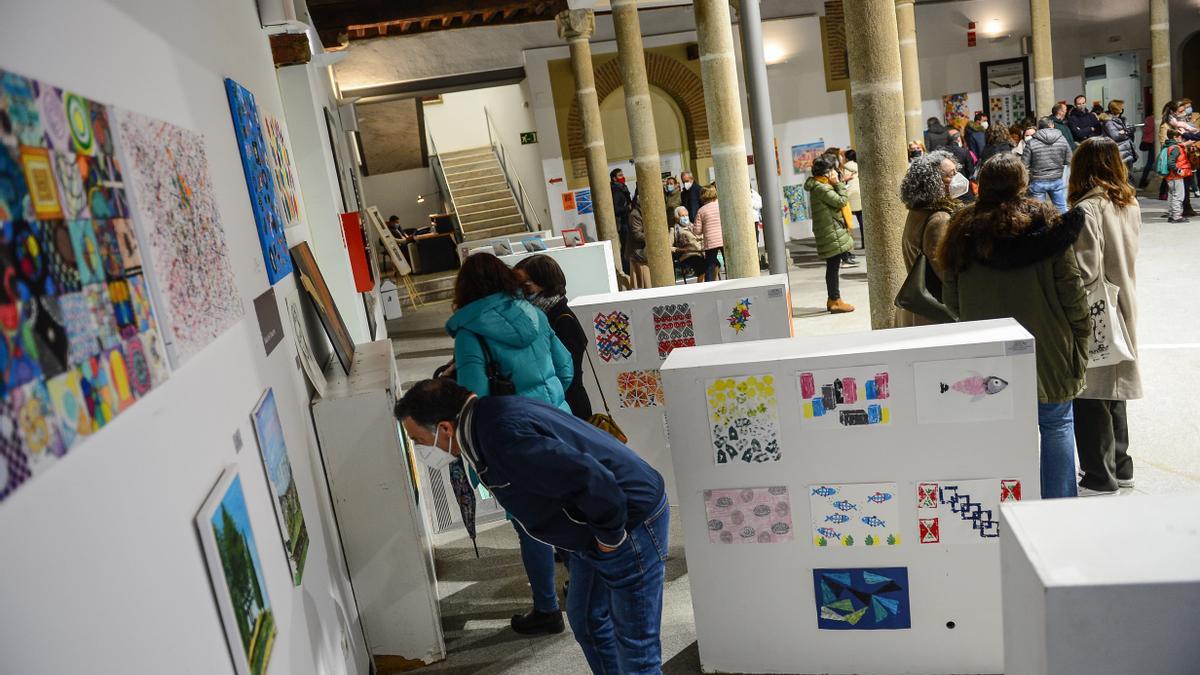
[611,0,674,286]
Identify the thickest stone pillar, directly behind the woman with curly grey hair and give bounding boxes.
[845,0,908,328]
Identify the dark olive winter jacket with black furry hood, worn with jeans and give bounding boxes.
[941,199,1092,404]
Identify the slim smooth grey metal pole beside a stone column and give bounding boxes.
[721,0,787,274]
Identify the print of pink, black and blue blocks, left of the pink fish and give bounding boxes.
[800,365,892,429]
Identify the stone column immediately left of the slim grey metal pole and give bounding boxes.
[694,0,753,279]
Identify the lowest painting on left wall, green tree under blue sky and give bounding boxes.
[196,466,277,675]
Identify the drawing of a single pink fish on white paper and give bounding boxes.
[913,357,1013,424]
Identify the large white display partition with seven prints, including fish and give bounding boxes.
[662,319,1039,674]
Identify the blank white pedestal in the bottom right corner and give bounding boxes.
[1001,495,1200,675]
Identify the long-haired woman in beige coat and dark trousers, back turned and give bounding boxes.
[1069,137,1141,497]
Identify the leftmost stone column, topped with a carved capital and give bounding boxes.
[554,10,623,275]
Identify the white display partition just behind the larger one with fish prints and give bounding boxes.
[573,273,792,506]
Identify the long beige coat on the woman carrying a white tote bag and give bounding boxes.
[1075,187,1141,401]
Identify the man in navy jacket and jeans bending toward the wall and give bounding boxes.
[395,378,670,674]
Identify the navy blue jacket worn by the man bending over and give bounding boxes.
[456,396,665,552]
